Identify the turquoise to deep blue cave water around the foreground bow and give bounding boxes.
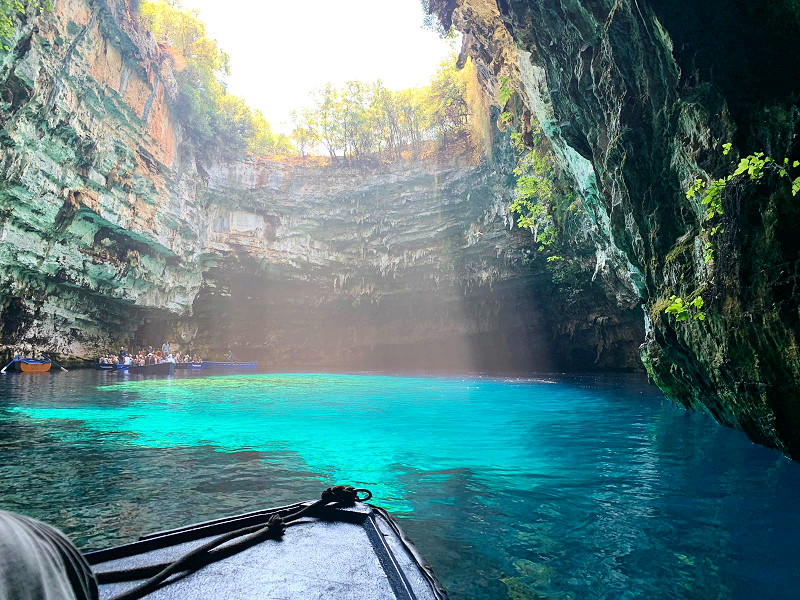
[0,371,800,600]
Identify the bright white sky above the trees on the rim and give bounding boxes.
[183,0,460,133]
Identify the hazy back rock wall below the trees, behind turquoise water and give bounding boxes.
[166,158,643,371]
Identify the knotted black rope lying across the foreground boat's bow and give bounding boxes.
[102,485,372,600]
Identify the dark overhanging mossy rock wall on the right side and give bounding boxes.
[442,0,800,457]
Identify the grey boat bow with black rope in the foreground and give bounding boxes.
[85,486,447,600]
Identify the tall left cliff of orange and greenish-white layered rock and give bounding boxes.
[0,0,207,356]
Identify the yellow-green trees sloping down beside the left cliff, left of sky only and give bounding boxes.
[140,0,296,155]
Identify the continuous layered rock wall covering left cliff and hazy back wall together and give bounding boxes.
[0,0,643,371]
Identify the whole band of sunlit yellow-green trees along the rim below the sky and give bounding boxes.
[141,0,480,162]
